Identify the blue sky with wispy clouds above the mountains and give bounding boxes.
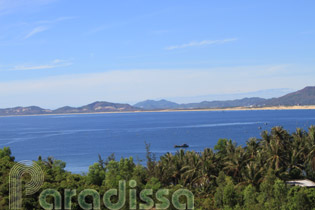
[0,0,315,108]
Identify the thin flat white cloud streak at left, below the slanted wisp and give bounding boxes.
[11,59,72,71]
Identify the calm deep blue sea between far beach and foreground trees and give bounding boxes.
[0,110,315,173]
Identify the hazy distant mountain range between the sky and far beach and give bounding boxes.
[0,86,315,116]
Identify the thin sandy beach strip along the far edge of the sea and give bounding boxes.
[0,105,315,117]
